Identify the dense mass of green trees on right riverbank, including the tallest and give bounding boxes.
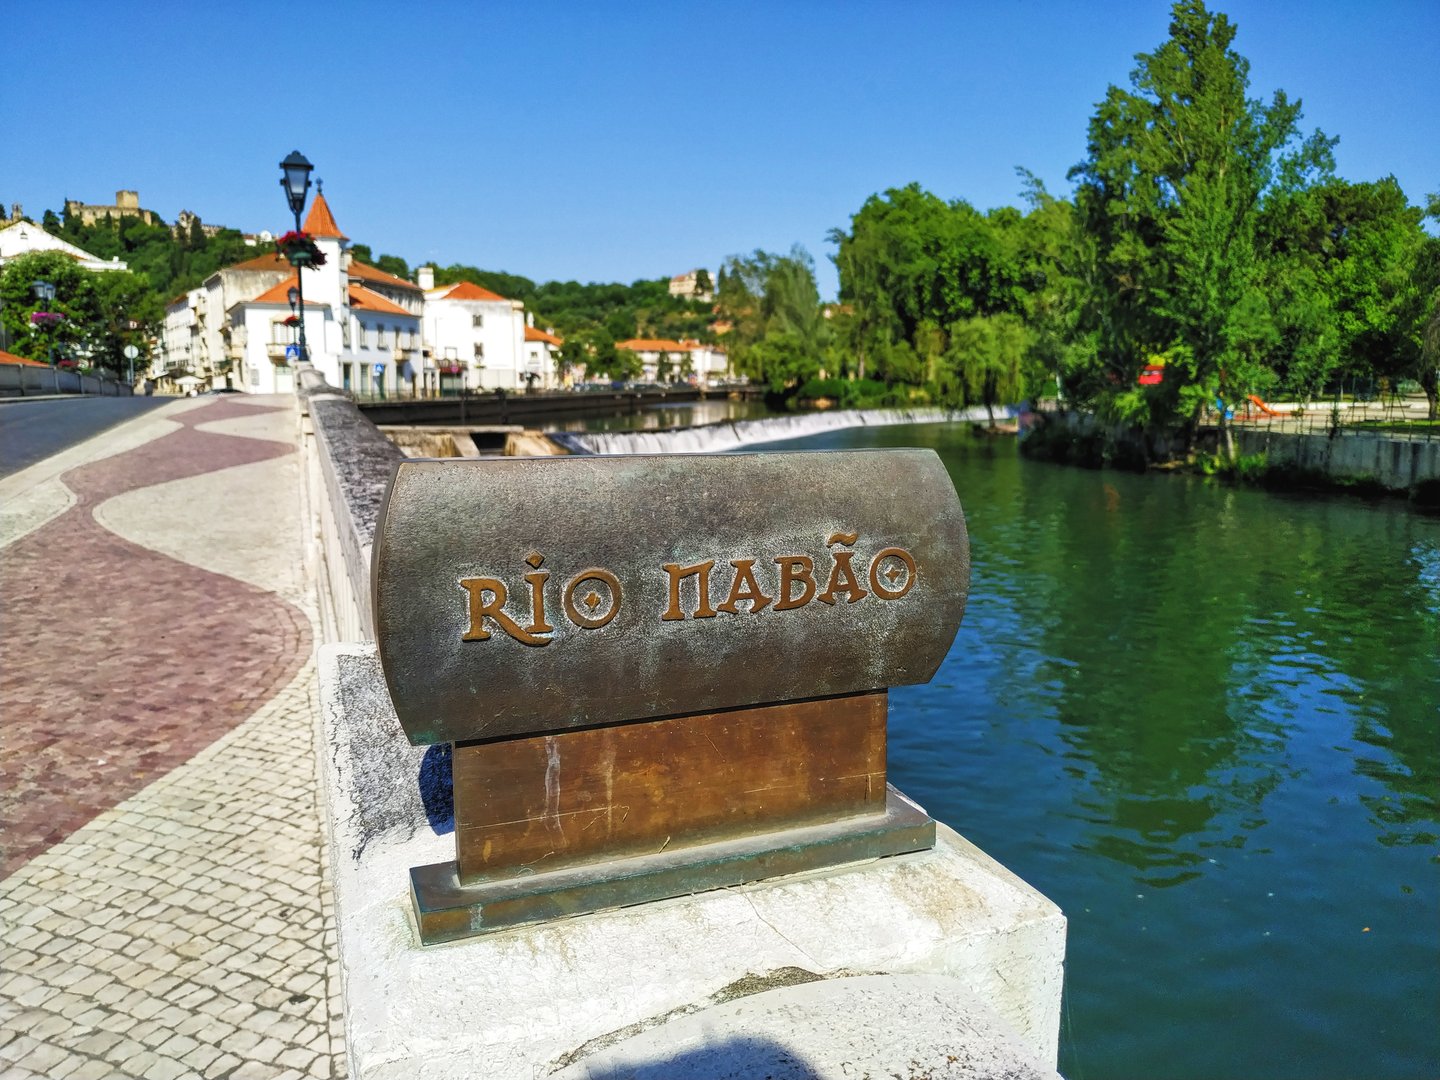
[829,0,1440,458]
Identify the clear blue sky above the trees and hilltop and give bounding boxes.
[0,0,1440,295]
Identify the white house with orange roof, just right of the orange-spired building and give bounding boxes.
[419,266,532,390]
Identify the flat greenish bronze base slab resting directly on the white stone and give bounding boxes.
[410,788,935,945]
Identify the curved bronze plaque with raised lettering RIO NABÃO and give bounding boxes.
[373,449,969,743]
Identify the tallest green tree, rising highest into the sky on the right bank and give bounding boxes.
[1071,0,1333,456]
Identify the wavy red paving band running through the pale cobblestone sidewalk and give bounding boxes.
[0,402,311,877]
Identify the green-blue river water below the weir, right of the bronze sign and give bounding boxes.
[564,423,1440,1080]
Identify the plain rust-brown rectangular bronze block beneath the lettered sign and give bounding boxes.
[454,691,886,883]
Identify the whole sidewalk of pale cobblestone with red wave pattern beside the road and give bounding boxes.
[0,399,344,1080]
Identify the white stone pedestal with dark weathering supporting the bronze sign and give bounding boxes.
[320,645,1066,1080]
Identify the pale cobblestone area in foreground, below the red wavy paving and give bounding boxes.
[0,664,344,1080]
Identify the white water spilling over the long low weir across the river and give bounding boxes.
[550,408,1015,454]
